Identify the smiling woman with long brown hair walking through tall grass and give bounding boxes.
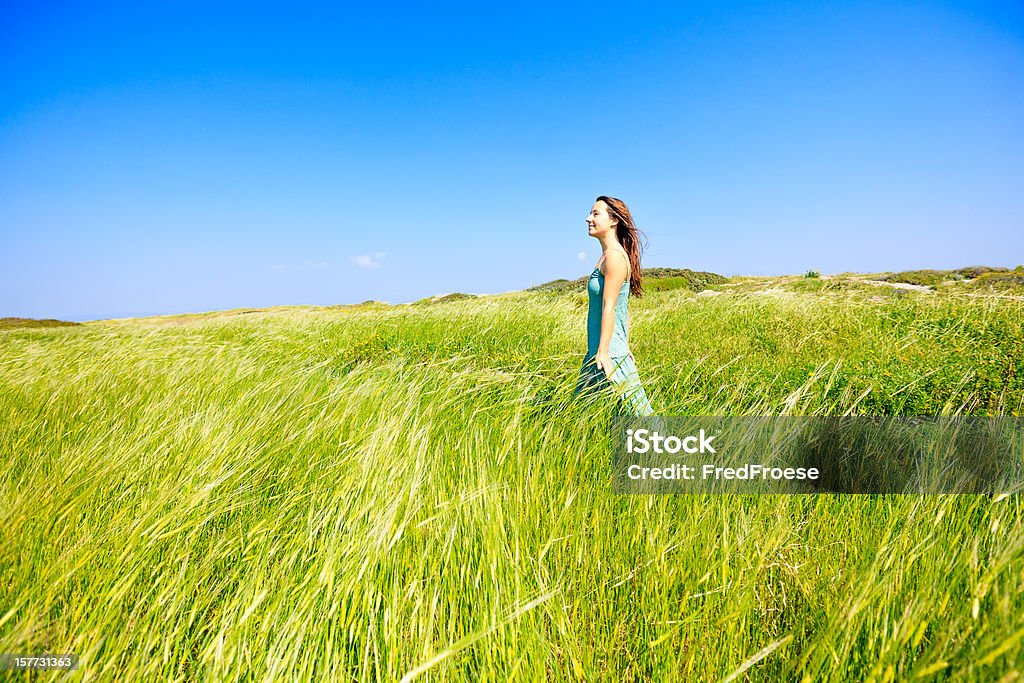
[575,195,654,417]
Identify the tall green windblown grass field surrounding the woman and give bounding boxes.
[0,275,1024,681]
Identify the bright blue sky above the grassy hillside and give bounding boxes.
[0,0,1024,321]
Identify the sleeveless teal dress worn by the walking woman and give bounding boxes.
[575,252,654,417]
